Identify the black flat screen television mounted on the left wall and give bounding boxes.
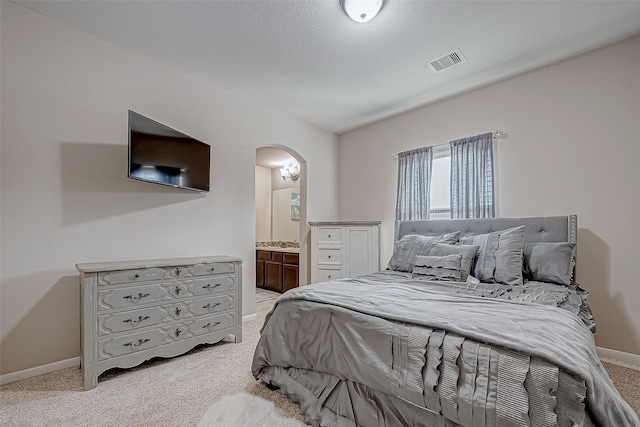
[127,110,211,192]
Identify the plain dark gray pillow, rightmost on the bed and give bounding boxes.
[524,242,576,286]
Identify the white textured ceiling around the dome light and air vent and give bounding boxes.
[16,0,640,134]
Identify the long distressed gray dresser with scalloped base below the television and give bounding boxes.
[76,256,242,390]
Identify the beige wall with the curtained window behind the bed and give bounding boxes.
[340,33,640,354]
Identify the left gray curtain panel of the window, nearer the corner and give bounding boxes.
[396,147,433,221]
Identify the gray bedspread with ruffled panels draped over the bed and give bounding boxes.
[252,272,640,426]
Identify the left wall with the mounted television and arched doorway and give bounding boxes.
[0,1,338,374]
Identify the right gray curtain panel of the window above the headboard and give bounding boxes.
[449,132,495,218]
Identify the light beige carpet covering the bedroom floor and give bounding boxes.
[0,299,640,427]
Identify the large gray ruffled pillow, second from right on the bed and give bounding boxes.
[460,225,525,285]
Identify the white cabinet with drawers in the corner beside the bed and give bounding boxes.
[309,221,380,283]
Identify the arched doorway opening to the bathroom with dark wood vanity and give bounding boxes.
[255,145,309,300]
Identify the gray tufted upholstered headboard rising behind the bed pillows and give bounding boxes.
[395,215,578,244]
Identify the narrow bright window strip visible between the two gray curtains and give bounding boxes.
[429,148,451,219]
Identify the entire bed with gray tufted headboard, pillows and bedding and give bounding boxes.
[252,215,640,427]
